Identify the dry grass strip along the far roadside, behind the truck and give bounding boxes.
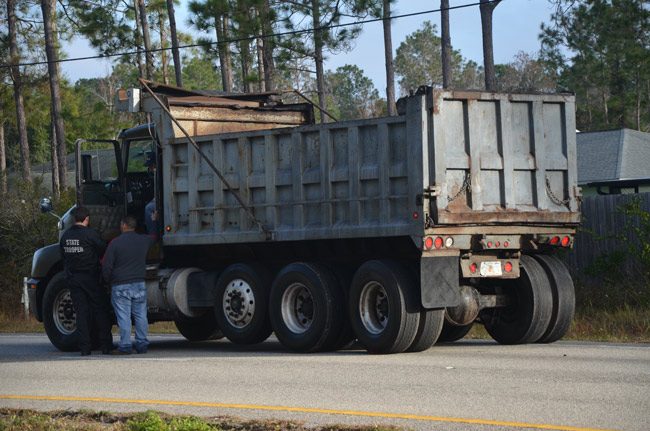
[0,306,650,344]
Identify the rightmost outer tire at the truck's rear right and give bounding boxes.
[535,255,576,343]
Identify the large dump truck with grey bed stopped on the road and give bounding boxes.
[26,81,580,353]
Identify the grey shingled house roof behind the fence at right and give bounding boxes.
[577,129,650,184]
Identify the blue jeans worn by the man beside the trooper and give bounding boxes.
[111,281,149,353]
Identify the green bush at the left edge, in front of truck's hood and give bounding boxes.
[0,178,74,315]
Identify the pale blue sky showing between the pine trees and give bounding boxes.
[61,0,553,93]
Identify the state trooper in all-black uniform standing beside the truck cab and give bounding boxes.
[59,206,113,356]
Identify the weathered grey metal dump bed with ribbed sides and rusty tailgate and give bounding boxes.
[152,89,579,245]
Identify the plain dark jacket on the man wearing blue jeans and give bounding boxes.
[102,232,154,286]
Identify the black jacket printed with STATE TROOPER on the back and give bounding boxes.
[59,224,106,277]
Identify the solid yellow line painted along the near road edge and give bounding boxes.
[0,394,612,431]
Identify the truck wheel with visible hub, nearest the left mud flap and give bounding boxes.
[348,260,420,353]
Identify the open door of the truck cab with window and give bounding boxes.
[75,139,125,240]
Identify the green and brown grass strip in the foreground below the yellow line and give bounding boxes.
[0,408,403,431]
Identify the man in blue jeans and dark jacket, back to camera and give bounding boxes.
[102,216,154,354]
